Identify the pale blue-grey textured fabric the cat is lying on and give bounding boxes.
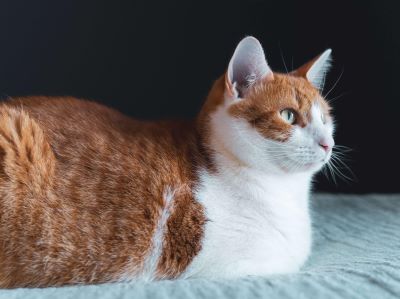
[0,194,400,299]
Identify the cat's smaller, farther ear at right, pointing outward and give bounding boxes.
[292,49,332,90]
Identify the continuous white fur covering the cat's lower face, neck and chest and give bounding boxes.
[182,99,333,278]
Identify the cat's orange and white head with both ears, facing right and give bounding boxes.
[204,37,334,173]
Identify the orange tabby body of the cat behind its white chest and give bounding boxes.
[0,97,204,287]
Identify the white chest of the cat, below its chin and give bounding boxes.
[186,170,311,277]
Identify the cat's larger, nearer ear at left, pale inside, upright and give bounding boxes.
[225,36,274,98]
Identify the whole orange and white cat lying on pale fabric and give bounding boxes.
[0,36,334,288]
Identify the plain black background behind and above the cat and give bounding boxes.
[0,0,400,193]
